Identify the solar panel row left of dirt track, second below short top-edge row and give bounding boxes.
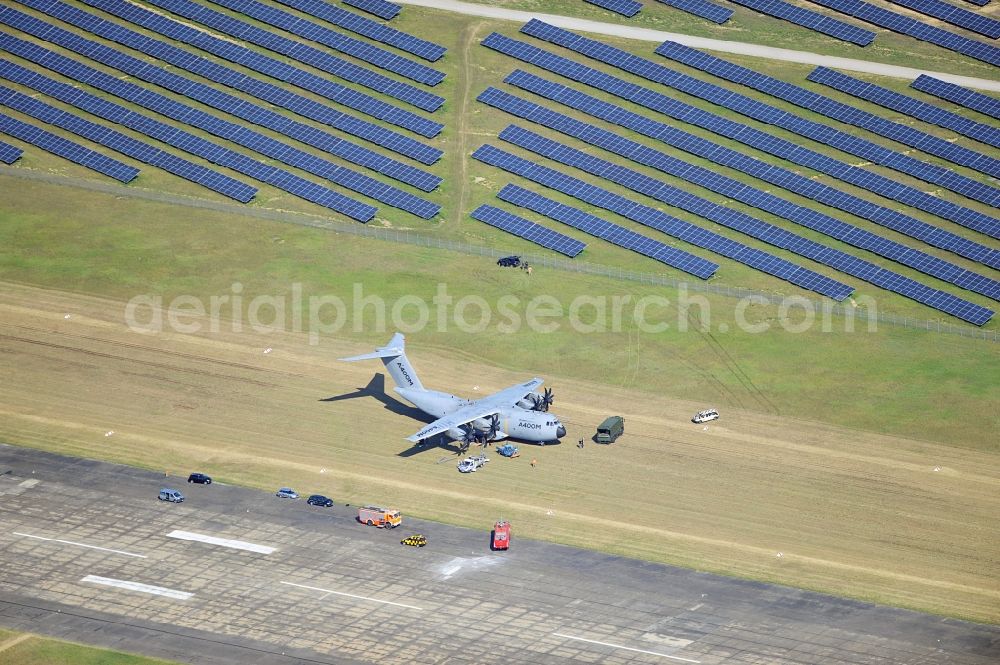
[208,0,444,85]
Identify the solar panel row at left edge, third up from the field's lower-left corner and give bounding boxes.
[0,78,257,203]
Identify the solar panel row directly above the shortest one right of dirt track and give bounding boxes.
[497,185,719,279]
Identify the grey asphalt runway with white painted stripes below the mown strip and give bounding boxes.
[0,446,1000,665]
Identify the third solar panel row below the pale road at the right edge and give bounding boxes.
[656,42,1000,179]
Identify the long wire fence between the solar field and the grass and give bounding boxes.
[7,167,1000,342]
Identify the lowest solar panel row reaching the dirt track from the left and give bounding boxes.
[0,35,440,219]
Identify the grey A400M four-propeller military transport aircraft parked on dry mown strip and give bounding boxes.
[341,333,566,448]
